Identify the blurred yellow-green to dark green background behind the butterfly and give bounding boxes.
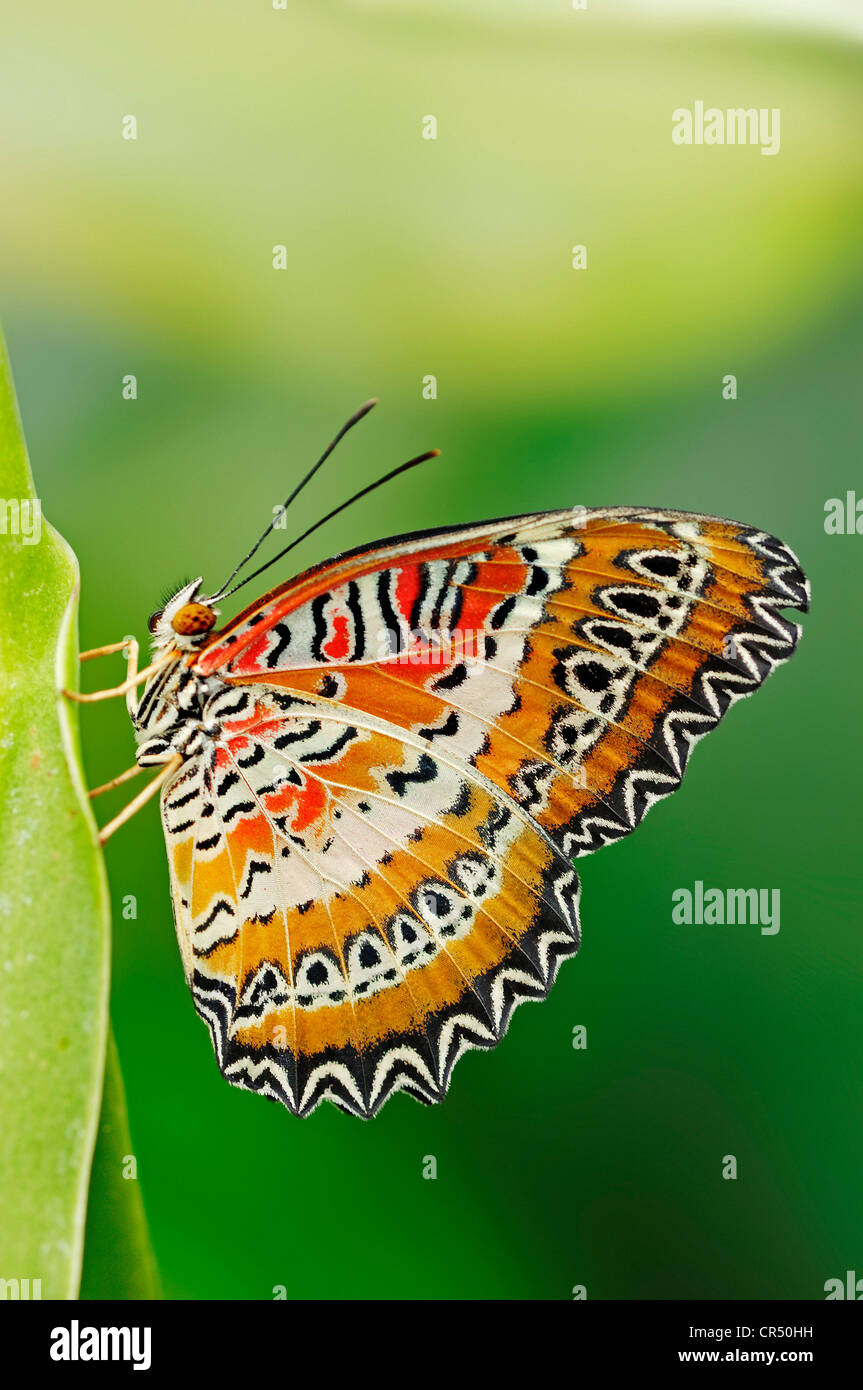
[0,0,863,1298]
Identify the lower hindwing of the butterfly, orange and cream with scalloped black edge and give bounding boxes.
[163,687,578,1115]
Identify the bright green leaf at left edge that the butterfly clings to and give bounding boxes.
[0,328,156,1298]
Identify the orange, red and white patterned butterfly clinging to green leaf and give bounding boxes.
[69,403,809,1118]
